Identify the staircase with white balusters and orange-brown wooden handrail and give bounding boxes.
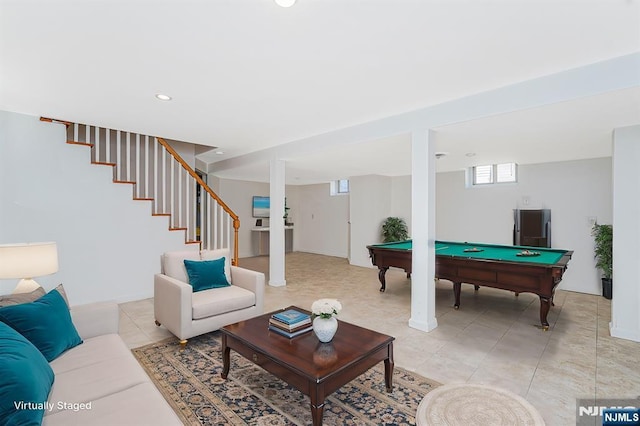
[40,117,240,265]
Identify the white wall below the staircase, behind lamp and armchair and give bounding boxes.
[0,111,193,304]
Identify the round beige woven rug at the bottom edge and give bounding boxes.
[416,383,544,426]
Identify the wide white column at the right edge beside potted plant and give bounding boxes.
[610,125,640,342]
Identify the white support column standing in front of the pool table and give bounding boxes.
[409,130,438,331]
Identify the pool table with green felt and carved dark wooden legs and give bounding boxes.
[367,240,573,330]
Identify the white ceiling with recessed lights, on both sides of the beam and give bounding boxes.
[0,0,640,184]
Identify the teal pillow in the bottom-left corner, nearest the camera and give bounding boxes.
[0,322,54,426]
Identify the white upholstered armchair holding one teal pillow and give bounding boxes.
[153,249,264,346]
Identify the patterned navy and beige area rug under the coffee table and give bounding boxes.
[133,332,439,425]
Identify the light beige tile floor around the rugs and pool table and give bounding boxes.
[120,252,640,425]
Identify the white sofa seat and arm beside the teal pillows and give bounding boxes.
[42,303,182,426]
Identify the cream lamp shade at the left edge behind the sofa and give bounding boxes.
[0,243,58,279]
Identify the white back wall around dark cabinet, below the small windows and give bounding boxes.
[436,158,613,294]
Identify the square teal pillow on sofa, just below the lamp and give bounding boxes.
[0,290,82,362]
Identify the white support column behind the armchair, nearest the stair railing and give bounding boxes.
[269,159,287,287]
